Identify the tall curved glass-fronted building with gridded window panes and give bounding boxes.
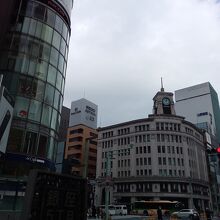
[0,0,73,176]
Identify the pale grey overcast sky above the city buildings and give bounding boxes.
[64,0,220,127]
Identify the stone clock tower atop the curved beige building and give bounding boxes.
[153,87,176,115]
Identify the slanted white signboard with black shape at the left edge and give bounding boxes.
[0,78,14,153]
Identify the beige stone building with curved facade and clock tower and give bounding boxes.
[96,89,211,209]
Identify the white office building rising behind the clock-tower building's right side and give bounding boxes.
[175,82,220,143]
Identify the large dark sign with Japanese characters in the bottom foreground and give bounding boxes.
[21,170,86,220]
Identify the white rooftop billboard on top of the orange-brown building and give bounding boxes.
[69,98,98,129]
